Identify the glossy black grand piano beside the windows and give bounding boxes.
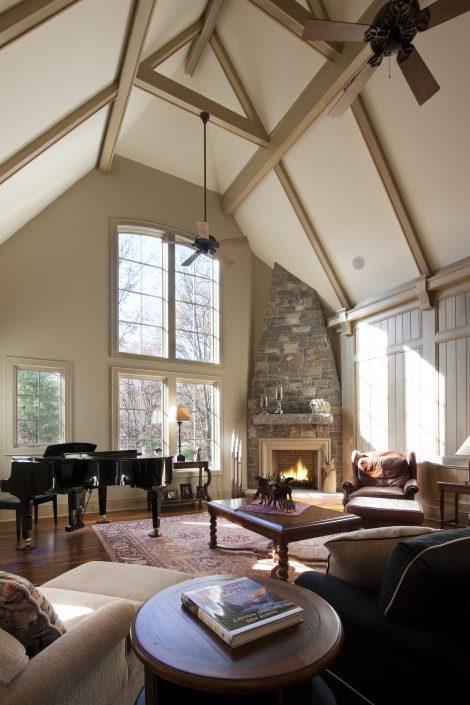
[0,443,173,548]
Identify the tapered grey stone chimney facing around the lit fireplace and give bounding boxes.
[247,264,343,488]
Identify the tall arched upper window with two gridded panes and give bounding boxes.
[113,224,220,363]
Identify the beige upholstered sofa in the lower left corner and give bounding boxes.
[0,561,191,705]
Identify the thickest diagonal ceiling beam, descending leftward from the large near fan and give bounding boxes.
[222,0,383,213]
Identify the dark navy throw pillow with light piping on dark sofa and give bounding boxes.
[379,529,470,623]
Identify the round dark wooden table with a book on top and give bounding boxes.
[131,575,343,705]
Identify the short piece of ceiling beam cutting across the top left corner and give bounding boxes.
[0,0,78,49]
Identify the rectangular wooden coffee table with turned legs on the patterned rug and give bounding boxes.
[207,498,361,580]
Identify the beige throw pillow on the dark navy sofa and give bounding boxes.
[325,526,437,592]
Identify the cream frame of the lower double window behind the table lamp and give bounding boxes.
[111,365,223,475]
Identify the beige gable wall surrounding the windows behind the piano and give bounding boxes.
[0,157,252,520]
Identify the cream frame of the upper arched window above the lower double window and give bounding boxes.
[110,219,222,367]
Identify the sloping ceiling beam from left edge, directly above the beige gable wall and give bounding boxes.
[0,83,118,184]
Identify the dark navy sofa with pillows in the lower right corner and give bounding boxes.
[296,526,470,705]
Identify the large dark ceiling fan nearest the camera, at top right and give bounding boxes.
[302,0,470,117]
